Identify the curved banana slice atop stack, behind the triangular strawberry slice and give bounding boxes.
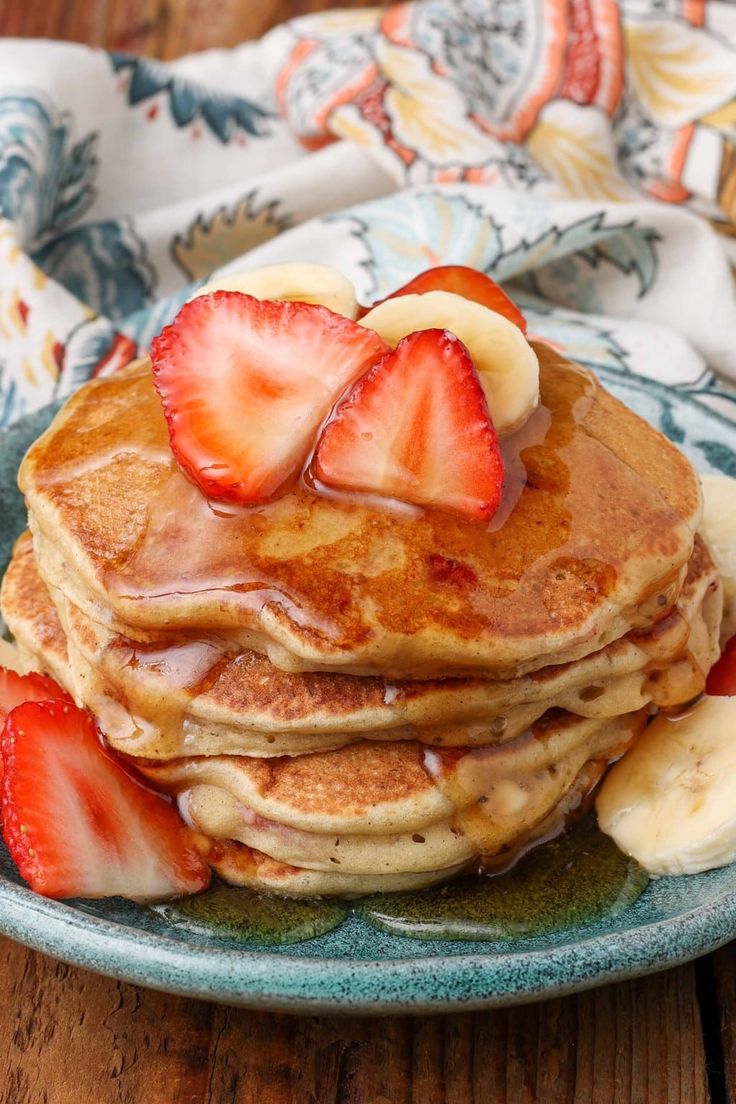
[361,291,540,436]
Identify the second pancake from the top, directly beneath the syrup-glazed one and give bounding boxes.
[1,534,719,758]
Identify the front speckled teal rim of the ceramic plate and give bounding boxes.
[0,880,736,1015]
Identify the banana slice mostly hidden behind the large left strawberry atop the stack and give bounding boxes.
[190,262,358,321]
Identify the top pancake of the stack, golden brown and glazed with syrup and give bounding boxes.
[19,346,701,678]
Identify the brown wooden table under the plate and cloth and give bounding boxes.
[0,0,736,1104]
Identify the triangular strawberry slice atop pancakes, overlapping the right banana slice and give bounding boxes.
[313,330,503,518]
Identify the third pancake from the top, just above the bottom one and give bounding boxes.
[141,711,646,892]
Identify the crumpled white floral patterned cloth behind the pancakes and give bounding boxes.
[0,0,736,474]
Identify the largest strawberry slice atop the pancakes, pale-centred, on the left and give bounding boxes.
[151,291,387,502]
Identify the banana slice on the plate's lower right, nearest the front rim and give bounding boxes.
[596,697,736,874]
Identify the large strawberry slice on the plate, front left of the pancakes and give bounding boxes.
[1,701,210,901]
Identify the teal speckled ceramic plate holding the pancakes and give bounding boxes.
[0,374,736,1012]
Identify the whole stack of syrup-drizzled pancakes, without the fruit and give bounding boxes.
[2,347,722,894]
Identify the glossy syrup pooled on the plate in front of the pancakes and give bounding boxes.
[157,817,649,945]
